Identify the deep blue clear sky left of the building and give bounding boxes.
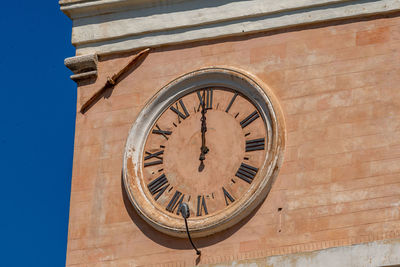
[0,0,76,266]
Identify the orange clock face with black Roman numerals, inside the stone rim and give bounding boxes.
[143,87,268,217]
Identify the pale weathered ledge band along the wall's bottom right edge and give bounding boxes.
[192,231,400,267]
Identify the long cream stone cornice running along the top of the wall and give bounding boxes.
[60,0,400,55]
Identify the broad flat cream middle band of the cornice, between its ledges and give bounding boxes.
[72,0,352,45]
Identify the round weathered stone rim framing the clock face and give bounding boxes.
[123,67,285,237]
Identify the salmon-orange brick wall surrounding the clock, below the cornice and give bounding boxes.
[67,14,400,266]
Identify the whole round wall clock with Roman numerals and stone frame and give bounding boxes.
[123,68,285,237]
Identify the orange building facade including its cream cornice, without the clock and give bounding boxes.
[60,0,400,266]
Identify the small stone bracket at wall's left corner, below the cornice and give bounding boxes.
[64,54,98,83]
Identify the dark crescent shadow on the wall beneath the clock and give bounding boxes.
[121,172,263,250]
